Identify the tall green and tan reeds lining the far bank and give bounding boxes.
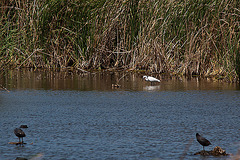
[0,0,240,82]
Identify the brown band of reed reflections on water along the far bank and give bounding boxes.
[0,70,239,91]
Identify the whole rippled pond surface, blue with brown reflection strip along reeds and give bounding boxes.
[0,72,240,160]
